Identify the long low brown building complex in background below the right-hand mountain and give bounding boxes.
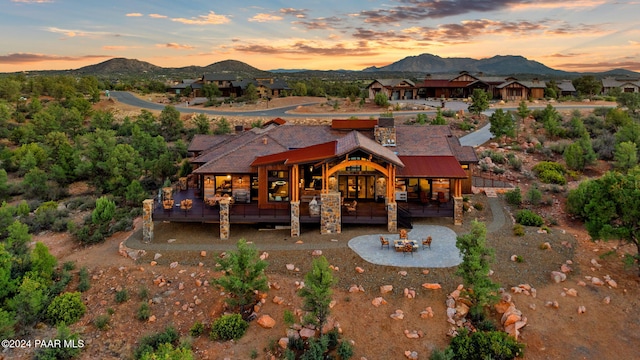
[367,71,546,100]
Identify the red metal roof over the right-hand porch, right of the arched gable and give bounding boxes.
[397,156,467,179]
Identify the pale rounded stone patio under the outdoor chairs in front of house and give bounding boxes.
[349,225,462,268]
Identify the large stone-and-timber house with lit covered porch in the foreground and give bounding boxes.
[141,118,478,242]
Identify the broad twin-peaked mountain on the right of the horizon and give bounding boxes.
[363,54,570,76]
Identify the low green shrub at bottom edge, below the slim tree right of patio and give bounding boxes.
[449,329,524,360]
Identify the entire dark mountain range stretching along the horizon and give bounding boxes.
[17,54,640,79]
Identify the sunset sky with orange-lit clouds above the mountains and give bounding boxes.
[0,0,640,72]
